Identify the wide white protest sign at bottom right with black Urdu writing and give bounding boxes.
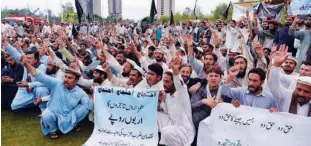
[198,103,311,146]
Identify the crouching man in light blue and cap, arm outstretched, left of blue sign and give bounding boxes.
[23,57,93,139]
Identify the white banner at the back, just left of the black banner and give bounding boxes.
[232,2,260,21]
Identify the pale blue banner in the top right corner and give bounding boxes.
[287,0,311,15]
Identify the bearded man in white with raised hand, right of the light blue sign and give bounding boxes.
[157,58,195,146]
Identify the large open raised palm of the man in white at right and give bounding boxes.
[272,45,288,67]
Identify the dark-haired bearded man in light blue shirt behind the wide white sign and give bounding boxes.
[221,66,278,109]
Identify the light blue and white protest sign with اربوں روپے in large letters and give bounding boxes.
[84,86,158,146]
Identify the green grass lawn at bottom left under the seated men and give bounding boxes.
[1,108,93,146]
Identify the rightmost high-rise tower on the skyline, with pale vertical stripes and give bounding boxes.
[157,0,175,18]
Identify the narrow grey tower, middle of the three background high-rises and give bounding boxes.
[108,0,122,19]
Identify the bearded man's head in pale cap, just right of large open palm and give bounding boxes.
[281,57,299,76]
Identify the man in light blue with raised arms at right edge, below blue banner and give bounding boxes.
[289,15,311,70]
